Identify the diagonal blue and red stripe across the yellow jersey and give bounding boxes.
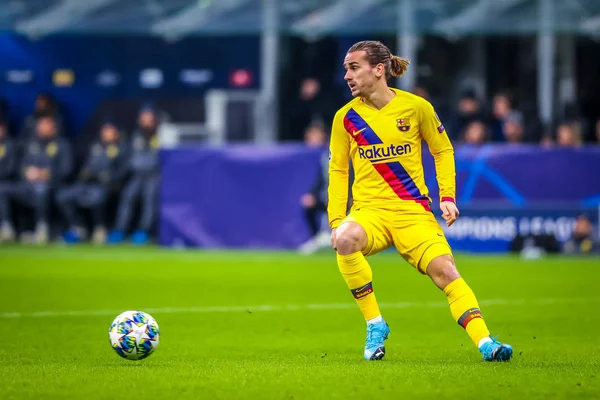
[344,109,431,211]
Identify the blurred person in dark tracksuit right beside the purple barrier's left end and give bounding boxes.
[108,105,160,244]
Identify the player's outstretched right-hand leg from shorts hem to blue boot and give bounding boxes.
[421,255,513,361]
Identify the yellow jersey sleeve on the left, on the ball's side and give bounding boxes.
[327,110,350,228]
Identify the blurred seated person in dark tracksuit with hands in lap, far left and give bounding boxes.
[0,115,72,244]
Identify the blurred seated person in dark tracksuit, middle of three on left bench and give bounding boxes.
[56,121,129,244]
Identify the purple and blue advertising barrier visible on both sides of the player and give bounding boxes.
[160,145,600,251]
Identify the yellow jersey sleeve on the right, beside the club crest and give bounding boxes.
[420,97,456,202]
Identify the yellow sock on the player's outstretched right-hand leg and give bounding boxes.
[444,278,490,346]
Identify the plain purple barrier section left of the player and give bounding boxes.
[160,146,321,249]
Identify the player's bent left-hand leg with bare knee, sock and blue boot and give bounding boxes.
[335,211,391,360]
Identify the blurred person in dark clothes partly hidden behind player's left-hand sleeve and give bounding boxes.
[299,124,331,254]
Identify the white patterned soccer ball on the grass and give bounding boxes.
[108,311,160,360]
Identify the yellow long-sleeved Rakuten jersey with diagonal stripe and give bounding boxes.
[328,89,456,228]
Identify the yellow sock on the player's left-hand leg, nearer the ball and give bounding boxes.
[337,251,381,321]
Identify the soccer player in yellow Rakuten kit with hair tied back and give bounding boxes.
[328,41,513,361]
